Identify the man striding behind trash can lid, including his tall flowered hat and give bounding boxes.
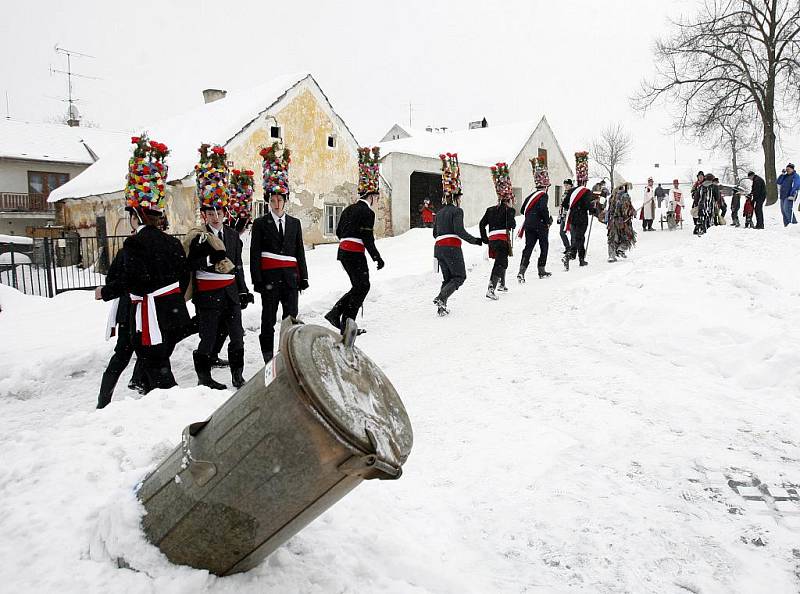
[325,147,385,334]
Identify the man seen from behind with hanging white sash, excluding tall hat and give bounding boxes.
[122,206,191,390]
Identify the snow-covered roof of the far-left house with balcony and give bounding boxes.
[0,119,128,165]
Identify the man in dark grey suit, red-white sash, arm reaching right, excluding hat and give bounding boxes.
[433,192,481,316]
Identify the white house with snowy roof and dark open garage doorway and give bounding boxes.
[379,117,573,235]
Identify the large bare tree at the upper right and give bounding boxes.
[633,0,800,204]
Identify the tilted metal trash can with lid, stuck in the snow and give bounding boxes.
[138,319,413,575]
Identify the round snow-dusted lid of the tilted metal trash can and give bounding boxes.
[286,324,413,467]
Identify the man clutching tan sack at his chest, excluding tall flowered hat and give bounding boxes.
[188,205,253,390]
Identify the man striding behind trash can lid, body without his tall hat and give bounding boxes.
[325,191,384,334]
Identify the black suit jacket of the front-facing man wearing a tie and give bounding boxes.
[250,212,308,291]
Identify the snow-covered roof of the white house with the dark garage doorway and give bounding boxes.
[378,120,541,166]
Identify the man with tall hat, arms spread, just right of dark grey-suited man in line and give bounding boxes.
[478,163,517,301]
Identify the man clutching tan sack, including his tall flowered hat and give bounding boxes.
[184,144,253,390]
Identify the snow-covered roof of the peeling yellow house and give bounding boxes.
[48,72,338,202]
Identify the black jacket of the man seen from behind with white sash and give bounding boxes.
[122,225,189,342]
